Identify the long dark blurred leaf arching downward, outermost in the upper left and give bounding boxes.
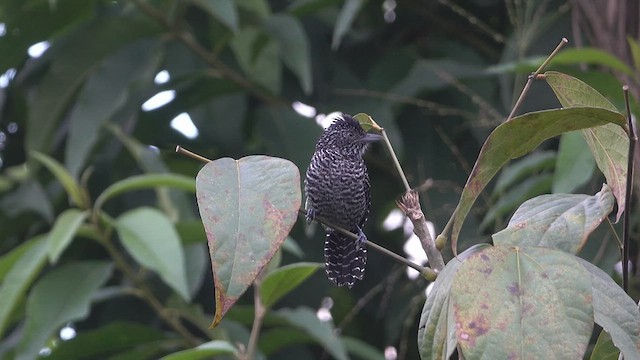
[25,16,159,152]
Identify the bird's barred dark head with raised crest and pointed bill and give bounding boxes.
[316,114,382,156]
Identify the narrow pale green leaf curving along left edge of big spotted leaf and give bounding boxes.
[418,244,490,360]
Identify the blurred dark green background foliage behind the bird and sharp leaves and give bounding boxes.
[0,0,640,359]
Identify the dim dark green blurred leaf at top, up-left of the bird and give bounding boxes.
[230,27,282,94]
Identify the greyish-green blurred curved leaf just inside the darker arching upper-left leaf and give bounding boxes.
[65,40,161,178]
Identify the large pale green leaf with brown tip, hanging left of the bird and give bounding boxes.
[196,156,301,326]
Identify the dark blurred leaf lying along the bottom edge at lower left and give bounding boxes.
[47,321,166,360]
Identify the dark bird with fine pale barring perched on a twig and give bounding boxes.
[304,114,382,289]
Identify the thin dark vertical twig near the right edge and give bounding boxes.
[622,85,638,292]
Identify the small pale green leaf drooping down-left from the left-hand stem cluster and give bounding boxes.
[47,209,89,264]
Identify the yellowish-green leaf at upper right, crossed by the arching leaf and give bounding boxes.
[545,71,629,220]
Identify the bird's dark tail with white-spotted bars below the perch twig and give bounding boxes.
[324,231,367,288]
